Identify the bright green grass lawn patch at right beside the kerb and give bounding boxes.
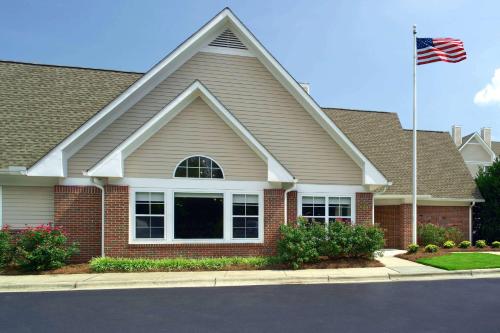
[416,253,500,271]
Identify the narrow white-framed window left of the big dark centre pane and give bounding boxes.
[135,192,165,238]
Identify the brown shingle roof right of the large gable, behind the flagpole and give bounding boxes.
[323,108,480,199]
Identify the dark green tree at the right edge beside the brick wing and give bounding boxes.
[474,158,500,242]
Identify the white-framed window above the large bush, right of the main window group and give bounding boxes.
[301,196,352,224]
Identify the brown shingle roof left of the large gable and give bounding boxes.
[0,61,142,169]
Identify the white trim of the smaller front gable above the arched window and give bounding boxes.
[85,81,294,182]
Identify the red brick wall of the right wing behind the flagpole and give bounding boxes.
[375,204,469,249]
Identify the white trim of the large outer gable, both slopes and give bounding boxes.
[27,8,388,185]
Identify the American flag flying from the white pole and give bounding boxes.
[417,38,467,65]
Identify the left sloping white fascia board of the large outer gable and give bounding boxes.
[26,9,228,177]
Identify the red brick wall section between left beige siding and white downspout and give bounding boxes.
[54,185,101,262]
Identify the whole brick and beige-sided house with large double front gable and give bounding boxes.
[0,8,480,261]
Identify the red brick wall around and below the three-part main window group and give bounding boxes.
[104,186,284,258]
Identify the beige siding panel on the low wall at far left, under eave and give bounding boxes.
[2,186,54,228]
